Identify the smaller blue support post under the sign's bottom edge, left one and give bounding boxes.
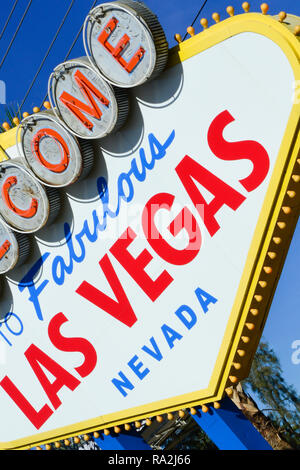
[93,430,151,450]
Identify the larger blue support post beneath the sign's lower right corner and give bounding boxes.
[192,398,272,450]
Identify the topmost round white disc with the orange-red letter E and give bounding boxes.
[83,0,168,88]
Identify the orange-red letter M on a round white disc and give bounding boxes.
[59,70,109,131]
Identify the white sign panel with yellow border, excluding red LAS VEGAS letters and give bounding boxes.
[0,14,300,448]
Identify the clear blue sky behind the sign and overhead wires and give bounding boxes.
[0,0,300,400]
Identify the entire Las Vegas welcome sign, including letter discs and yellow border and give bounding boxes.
[0,2,300,448]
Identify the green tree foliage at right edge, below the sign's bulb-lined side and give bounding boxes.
[243,340,300,449]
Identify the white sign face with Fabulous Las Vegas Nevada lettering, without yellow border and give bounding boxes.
[0,32,294,447]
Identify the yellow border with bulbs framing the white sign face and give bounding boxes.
[0,13,300,449]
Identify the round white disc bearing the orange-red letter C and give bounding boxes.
[0,162,49,233]
